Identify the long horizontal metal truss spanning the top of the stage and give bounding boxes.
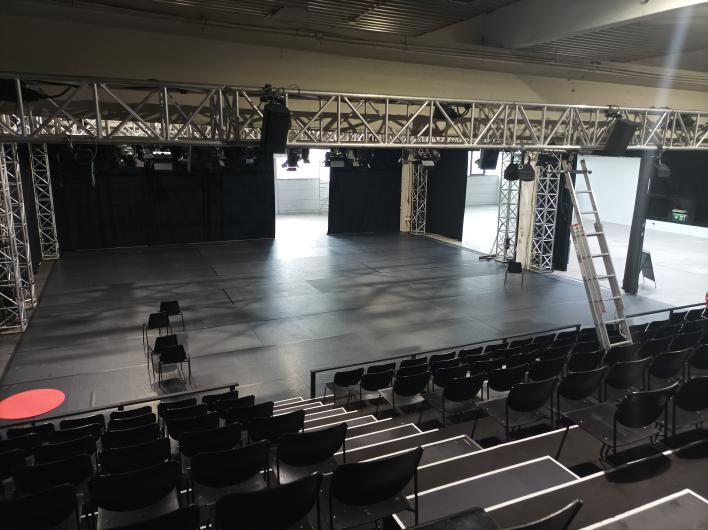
[0,74,708,151]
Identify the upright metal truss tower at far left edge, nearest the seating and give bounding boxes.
[0,144,27,332]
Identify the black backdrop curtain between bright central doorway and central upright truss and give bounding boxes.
[327,149,401,234]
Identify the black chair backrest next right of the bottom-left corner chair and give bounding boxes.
[89,462,179,512]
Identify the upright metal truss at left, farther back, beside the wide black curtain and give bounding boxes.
[29,144,59,259]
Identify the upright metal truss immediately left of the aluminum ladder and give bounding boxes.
[529,152,563,272]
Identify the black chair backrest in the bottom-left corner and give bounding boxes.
[0,484,81,530]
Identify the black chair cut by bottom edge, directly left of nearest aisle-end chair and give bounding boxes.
[214,473,322,530]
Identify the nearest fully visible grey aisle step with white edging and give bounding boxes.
[397,456,578,528]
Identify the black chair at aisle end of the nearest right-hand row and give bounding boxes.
[482,377,558,440]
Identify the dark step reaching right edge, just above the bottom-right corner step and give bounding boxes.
[484,440,708,528]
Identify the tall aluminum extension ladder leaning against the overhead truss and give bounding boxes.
[562,160,632,351]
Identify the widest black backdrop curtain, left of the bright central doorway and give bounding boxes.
[50,146,275,250]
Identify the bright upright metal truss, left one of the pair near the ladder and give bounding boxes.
[493,151,521,262]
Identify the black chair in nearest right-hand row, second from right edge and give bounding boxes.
[556,383,678,460]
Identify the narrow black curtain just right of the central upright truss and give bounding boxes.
[426,149,469,241]
